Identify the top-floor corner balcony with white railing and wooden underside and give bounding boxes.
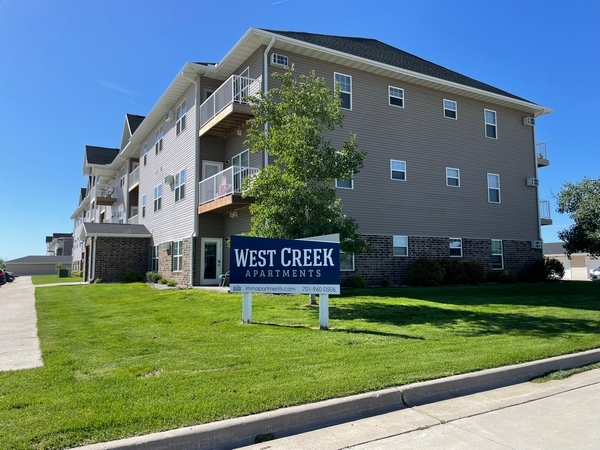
[199,75,262,139]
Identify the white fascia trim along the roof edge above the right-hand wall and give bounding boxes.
[253,28,554,117]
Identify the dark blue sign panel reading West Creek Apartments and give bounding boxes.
[229,236,340,294]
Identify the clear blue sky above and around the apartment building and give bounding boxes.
[0,0,600,260]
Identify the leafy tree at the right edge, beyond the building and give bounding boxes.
[556,177,600,258]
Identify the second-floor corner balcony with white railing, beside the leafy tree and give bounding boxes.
[198,166,260,214]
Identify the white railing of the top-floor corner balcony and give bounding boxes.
[200,75,261,128]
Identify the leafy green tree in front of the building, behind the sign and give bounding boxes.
[244,67,367,253]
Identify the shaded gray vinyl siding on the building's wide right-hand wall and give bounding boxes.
[262,52,539,240]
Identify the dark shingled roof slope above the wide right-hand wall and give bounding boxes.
[264,30,532,103]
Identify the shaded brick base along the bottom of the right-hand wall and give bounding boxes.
[341,235,542,286]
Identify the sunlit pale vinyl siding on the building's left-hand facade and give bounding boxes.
[139,85,197,244]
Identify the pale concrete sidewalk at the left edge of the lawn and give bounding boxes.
[0,277,44,371]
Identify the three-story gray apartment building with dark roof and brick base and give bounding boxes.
[72,28,551,285]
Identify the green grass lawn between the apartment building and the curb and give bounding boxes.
[0,282,600,449]
